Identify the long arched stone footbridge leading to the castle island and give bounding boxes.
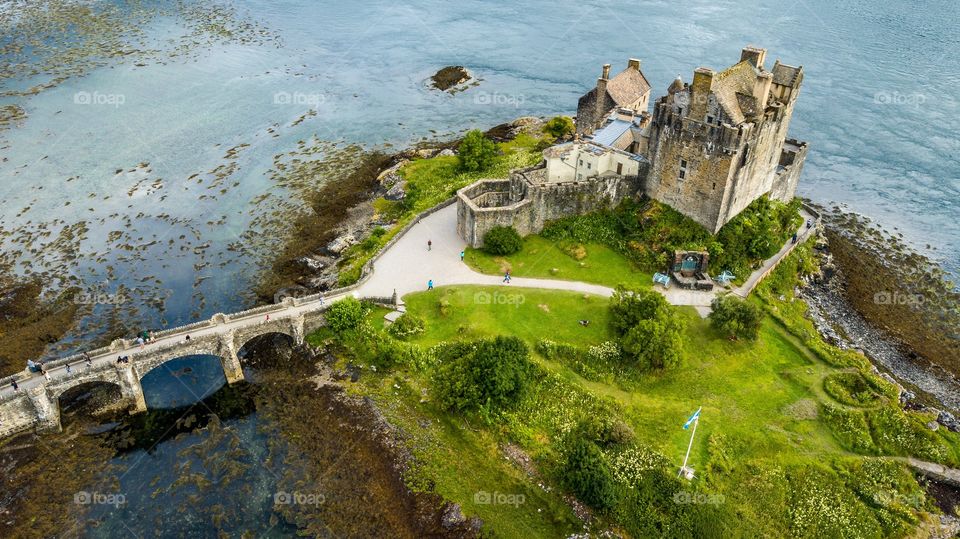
[0,292,398,438]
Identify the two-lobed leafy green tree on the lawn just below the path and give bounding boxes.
[610,286,683,370]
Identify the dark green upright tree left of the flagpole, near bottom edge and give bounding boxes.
[563,436,617,509]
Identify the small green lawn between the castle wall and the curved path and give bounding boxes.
[464,235,653,288]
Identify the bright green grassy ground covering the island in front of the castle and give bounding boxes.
[311,244,960,537]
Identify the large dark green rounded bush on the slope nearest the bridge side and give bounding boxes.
[434,337,533,411]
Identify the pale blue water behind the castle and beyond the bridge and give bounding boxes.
[0,0,960,334]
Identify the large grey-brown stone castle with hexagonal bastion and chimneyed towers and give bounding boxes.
[457,47,807,247]
